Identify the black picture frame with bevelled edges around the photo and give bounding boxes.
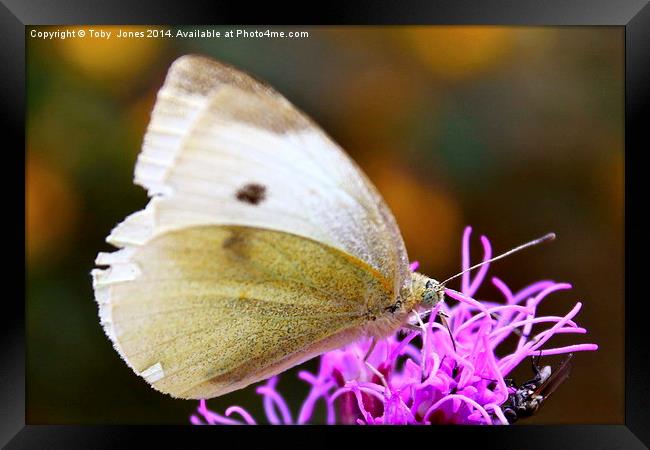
[0,0,650,449]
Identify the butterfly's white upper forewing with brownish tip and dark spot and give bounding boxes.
[129,56,410,288]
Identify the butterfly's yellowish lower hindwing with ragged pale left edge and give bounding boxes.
[95,226,392,398]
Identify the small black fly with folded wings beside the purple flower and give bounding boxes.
[502,353,573,424]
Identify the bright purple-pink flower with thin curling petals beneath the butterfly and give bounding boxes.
[190,227,598,425]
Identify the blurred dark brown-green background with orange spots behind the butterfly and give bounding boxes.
[26,26,624,424]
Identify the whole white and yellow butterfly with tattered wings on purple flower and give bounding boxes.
[92,55,548,399]
